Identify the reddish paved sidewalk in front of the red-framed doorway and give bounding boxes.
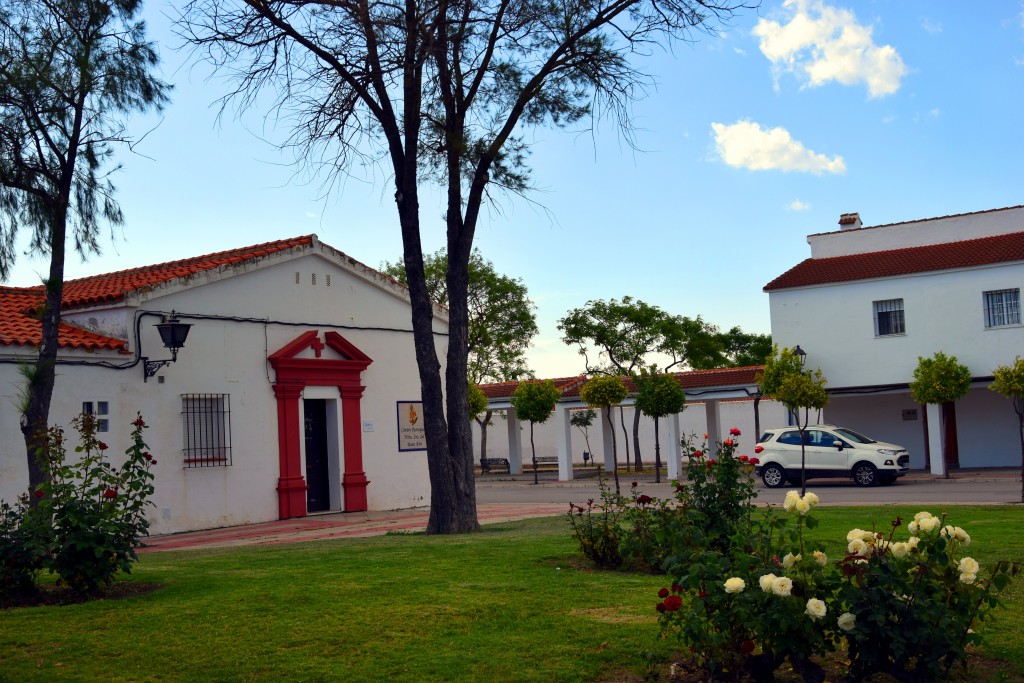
[139,503,568,552]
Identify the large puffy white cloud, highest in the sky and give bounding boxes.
[754,0,906,97]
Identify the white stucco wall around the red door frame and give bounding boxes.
[0,250,446,533]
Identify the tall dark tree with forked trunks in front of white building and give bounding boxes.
[178,0,739,533]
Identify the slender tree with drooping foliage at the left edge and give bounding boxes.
[0,0,169,486]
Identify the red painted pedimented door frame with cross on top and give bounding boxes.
[268,330,373,519]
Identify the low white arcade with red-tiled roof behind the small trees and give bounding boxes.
[473,366,786,481]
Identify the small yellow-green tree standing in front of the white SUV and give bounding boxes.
[758,346,828,496]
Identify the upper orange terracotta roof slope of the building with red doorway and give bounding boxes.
[58,234,312,308]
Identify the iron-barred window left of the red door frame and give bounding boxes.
[181,393,231,467]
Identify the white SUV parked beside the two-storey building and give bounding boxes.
[754,425,910,488]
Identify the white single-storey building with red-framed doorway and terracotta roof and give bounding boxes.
[0,236,447,533]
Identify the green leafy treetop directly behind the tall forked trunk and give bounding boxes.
[381,249,539,383]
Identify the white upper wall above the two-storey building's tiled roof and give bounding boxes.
[807,207,1024,258]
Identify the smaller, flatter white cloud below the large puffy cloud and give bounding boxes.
[711,121,846,175]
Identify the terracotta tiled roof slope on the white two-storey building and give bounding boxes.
[764,232,1024,292]
